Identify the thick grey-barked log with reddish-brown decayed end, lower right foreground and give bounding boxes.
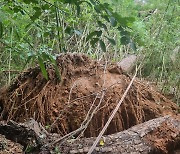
[60,116,180,154]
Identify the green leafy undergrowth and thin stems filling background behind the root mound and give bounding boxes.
[0,0,180,102]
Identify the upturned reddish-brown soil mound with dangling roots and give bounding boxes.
[0,53,178,137]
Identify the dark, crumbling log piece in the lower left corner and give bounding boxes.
[0,119,48,149]
